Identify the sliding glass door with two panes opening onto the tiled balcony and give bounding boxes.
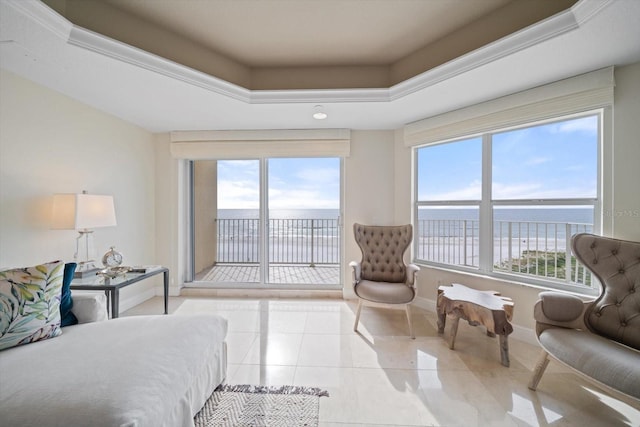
[192,158,341,289]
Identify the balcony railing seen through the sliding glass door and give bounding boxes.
[217,218,340,266]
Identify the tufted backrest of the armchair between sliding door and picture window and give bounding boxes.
[353,223,413,282]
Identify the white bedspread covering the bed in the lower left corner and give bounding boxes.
[0,315,227,427]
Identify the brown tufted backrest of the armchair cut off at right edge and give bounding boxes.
[571,233,640,350]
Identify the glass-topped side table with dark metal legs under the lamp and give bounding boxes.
[70,267,169,319]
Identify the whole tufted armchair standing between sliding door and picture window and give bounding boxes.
[349,224,420,338]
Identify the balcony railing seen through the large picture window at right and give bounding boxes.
[417,219,593,287]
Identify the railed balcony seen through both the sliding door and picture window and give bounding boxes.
[196,218,593,288]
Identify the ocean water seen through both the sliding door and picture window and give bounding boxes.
[218,207,593,265]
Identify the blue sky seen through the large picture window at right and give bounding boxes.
[418,116,598,200]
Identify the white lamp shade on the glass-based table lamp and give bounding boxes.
[51,194,116,230]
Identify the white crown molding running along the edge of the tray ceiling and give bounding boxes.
[5,0,613,108]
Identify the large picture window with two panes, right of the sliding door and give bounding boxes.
[414,112,602,289]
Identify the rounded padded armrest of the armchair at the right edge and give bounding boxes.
[533,292,593,329]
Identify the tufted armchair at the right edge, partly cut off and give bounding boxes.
[529,233,640,399]
